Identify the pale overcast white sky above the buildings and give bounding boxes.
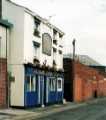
[12,0,106,65]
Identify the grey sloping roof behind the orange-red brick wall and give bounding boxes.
[64,54,102,66]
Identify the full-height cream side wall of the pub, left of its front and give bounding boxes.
[2,0,24,106]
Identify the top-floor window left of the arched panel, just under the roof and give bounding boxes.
[34,18,40,37]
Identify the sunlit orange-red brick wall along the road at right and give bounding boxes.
[73,62,106,102]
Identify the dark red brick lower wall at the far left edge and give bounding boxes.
[0,59,7,108]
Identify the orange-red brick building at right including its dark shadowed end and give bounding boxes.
[64,58,106,102]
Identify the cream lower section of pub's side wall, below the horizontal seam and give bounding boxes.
[10,65,24,106]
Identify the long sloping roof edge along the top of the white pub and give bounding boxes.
[7,0,65,35]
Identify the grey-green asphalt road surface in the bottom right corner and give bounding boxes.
[36,101,106,120]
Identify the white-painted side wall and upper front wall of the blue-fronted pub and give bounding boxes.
[2,0,62,106]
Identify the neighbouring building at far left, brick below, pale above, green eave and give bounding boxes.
[0,19,11,108]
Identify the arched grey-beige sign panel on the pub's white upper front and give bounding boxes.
[42,33,52,56]
